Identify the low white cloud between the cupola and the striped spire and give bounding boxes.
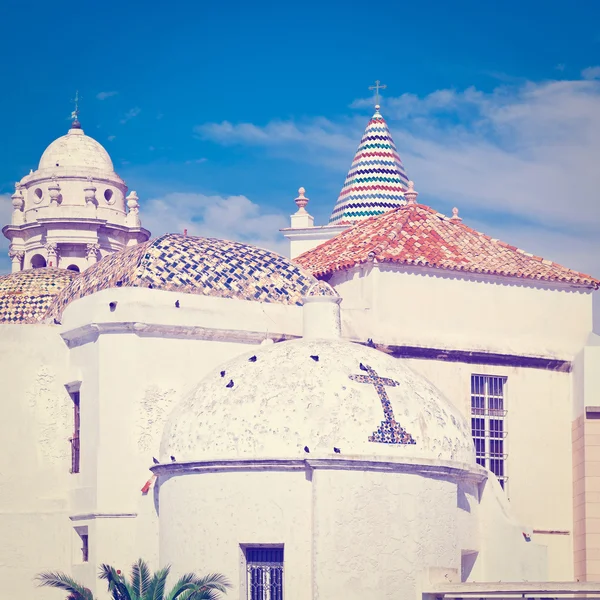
[140,192,288,254]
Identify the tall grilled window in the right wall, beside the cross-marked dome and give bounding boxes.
[471,375,508,488]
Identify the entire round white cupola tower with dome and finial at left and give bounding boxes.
[2,110,150,272]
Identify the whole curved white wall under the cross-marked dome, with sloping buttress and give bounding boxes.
[160,465,545,600]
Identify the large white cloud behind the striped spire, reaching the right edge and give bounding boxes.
[196,77,600,275]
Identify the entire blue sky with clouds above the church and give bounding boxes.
[0,0,600,276]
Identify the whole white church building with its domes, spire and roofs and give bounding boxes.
[0,107,600,600]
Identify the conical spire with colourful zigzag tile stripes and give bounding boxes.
[329,106,408,225]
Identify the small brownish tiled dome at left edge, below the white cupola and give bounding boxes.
[0,267,79,325]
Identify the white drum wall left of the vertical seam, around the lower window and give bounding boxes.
[160,472,312,600]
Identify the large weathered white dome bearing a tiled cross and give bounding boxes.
[161,339,475,464]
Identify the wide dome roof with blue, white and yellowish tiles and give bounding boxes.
[48,234,317,317]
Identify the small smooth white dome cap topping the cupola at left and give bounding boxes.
[38,129,114,174]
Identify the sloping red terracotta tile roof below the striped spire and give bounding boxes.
[294,204,600,289]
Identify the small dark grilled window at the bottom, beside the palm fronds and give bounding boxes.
[246,547,283,600]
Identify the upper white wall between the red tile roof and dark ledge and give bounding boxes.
[330,265,592,358]
